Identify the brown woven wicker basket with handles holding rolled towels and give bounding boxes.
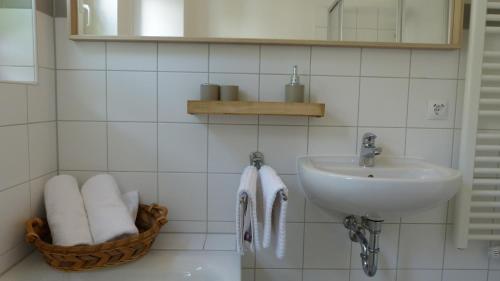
[26,205,168,271]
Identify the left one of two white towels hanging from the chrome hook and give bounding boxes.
[236,166,260,255]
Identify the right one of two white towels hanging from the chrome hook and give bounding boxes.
[259,166,288,259]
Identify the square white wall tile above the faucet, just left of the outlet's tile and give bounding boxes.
[359,78,409,127]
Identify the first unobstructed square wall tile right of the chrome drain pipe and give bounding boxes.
[399,224,446,269]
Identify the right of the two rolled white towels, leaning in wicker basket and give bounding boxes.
[82,175,138,243]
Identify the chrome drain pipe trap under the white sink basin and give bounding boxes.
[344,216,382,277]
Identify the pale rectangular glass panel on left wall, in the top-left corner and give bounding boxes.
[0,0,37,83]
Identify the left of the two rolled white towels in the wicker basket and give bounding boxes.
[44,175,93,246]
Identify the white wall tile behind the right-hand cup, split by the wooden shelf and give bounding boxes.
[209,73,259,124]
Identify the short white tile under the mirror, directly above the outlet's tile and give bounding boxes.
[410,50,459,79]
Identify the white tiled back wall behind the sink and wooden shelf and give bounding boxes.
[48,14,500,281]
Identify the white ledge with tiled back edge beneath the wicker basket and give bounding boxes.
[0,233,241,281]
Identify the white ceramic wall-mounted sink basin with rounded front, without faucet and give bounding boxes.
[297,156,462,219]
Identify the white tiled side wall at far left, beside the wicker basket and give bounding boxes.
[0,12,58,274]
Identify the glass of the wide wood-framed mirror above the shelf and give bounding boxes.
[72,0,457,44]
